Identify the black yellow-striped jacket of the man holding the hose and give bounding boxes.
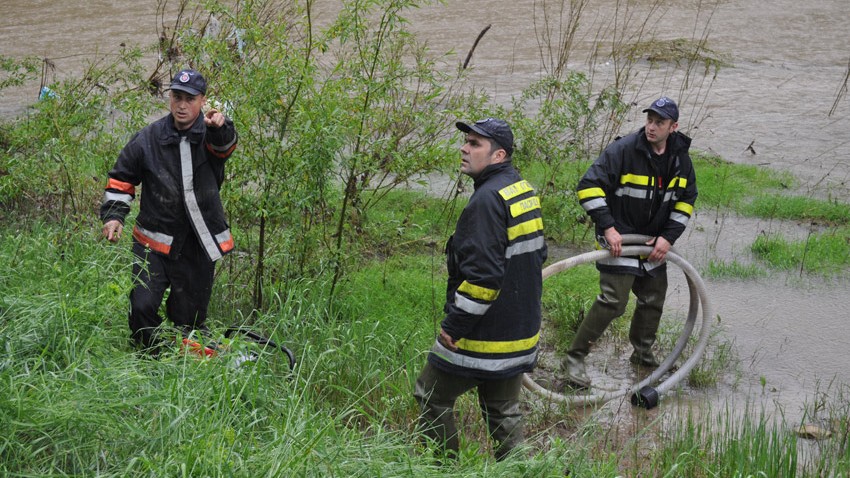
[576,128,697,276]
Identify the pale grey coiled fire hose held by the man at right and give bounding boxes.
[523,234,713,409]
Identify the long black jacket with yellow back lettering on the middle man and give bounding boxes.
[428,162,547,379]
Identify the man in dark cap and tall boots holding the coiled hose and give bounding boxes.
[563,97,697,388]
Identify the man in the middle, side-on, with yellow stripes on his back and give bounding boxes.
[414,118,547,459]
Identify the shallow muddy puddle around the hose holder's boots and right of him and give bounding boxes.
[533,209,850,426]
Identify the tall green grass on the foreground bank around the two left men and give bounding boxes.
[0,216,850,477]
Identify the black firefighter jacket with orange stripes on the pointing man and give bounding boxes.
[100,114,237,261]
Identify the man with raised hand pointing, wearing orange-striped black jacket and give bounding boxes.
[100,69,237,353]
